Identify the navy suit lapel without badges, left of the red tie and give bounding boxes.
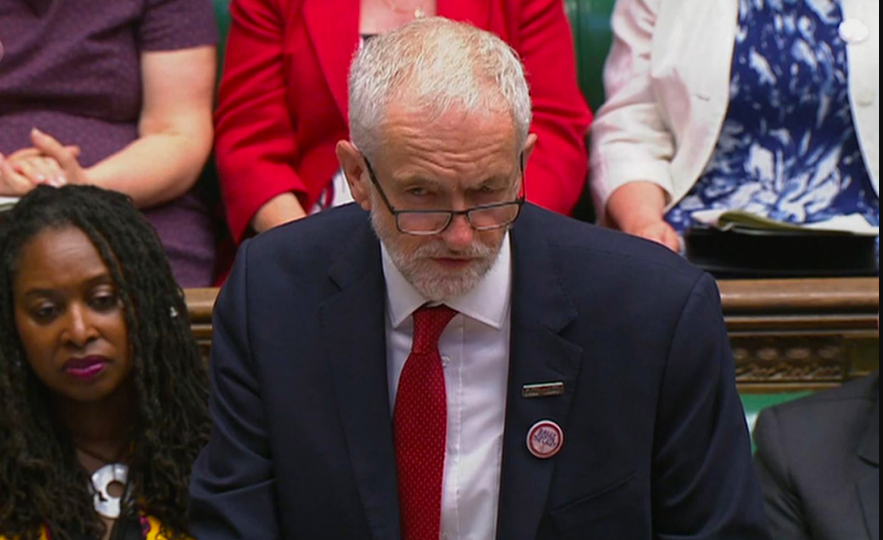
[320,220,400,540]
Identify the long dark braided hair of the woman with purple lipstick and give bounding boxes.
[0,186,209,540]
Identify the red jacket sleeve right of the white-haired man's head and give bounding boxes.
[515,0,592,214]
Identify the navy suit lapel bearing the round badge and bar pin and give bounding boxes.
[497,208,583,539]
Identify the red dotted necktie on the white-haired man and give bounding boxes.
[394,306,457,540]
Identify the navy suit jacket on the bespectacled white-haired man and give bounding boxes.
[191,205,767,540]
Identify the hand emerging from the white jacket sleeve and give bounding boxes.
[607,182,681,253]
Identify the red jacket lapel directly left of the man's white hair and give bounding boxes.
[303,0,361,122]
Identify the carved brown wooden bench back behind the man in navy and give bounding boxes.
[186,279,880,393]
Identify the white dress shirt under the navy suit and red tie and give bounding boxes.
[382,234,512,540]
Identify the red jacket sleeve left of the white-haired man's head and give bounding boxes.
[215,0,306,241]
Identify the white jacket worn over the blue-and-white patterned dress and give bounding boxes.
[591,0,880,215]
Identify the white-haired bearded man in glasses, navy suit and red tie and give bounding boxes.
[191,19,766,540]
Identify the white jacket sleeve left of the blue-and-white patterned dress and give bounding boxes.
[590,0,676,216]
